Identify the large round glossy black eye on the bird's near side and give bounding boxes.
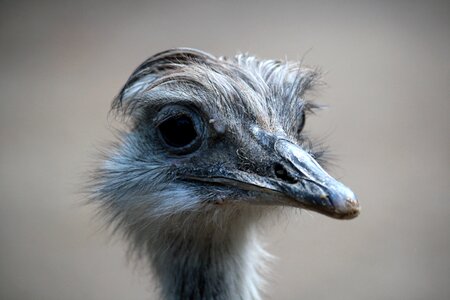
[159,116,197,148]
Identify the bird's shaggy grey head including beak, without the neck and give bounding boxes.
[99,49,359,223]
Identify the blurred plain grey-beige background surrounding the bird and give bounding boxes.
[0,1,450,300]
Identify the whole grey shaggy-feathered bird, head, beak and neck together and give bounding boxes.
[92,48,359,299]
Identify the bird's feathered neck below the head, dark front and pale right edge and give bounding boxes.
[149,211,265,300]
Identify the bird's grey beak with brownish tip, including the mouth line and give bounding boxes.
[182,128,360,219]
